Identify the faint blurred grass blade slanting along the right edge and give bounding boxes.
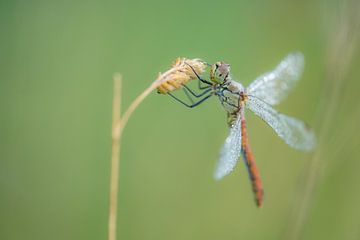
[284,2,360,240]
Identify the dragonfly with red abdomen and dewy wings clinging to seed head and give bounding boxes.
[162,52,316,207]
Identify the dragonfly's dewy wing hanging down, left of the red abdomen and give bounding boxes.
[214,114,241,180]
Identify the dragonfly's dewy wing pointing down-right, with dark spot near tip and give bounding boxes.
[246,96,316,151]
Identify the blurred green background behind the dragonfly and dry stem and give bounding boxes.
[0,0,360,240]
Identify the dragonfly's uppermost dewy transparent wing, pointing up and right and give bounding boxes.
[247,52,304,105]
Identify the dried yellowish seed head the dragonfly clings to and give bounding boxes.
[155,58,206,94]
